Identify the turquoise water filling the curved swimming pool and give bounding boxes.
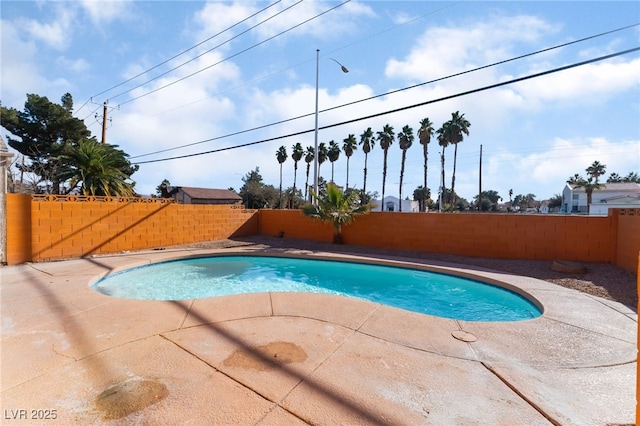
[92,256,541,321]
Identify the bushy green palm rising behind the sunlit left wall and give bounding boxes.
[59,139,138,197]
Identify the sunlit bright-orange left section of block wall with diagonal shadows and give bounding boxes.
[7,194,259,265]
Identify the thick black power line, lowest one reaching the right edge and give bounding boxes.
[133,47,640,164]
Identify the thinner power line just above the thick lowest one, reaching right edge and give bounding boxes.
[131,23,640,159]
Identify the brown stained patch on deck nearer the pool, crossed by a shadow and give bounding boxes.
[223,342,307,371]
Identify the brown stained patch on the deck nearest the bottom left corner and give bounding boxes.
[94,379,169,420]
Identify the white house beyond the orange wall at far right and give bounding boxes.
[561,182,640,216]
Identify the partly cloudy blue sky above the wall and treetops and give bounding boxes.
[0,0,640,201]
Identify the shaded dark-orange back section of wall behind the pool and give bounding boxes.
[260,210,616,264]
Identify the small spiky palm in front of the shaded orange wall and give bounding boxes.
[302,182,371,244]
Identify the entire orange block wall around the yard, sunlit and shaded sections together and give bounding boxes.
[7,194,640,273]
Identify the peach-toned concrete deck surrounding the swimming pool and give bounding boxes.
[0,238,637,426]
